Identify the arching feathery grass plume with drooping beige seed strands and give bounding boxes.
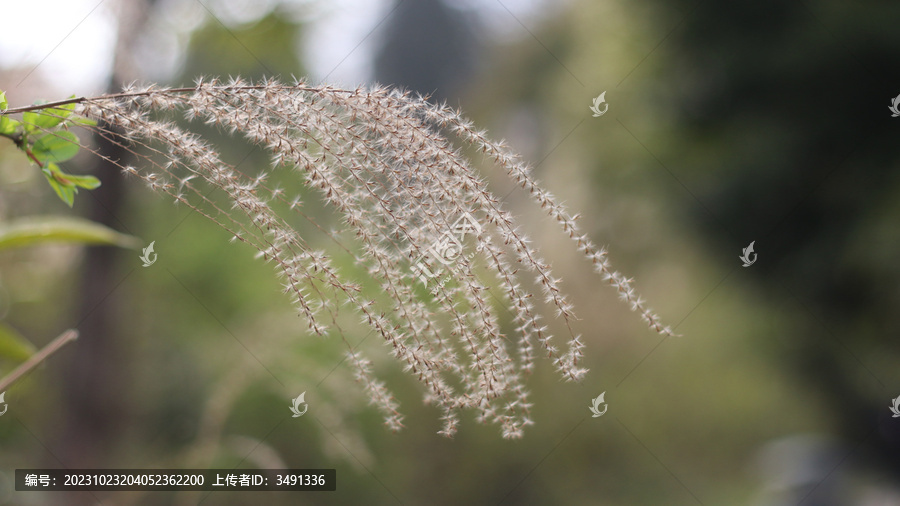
[5,79,672,438]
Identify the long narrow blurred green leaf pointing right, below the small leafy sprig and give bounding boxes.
[0,216,142,250]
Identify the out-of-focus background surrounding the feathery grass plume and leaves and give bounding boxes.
[0,0,900,506]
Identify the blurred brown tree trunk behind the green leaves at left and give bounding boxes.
[55,0,155,478]
